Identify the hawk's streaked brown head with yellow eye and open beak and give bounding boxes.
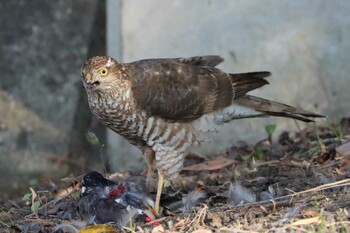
[81,56,121,92]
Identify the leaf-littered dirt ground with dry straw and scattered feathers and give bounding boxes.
[0,118,350,233]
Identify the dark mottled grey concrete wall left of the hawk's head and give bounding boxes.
[0,0,98,197]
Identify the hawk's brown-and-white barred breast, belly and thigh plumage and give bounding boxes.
[88,78,195,180]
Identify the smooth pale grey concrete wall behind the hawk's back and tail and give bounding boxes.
[109,0,350,166]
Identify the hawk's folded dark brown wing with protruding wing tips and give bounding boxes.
[128,56,269,121]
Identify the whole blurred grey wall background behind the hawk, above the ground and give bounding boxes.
[0,0,350,198]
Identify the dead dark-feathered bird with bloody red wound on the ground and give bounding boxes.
[78,171,155,225]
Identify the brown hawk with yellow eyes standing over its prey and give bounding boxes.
[81,55,323,212]
